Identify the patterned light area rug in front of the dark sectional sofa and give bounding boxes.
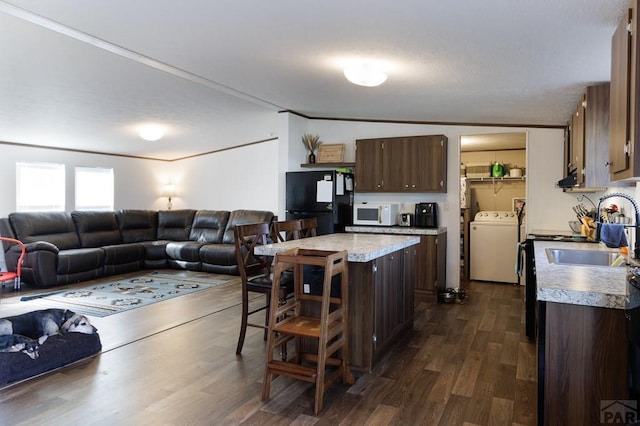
[20,272,228,317]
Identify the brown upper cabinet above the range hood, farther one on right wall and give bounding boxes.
[567,83,611,191]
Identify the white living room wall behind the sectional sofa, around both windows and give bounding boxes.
[0,139,279,217]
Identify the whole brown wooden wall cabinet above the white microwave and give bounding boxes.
[355,135,447,192]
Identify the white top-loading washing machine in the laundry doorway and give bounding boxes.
[469,211,520,284]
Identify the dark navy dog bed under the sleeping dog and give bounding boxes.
[0,317,102,387]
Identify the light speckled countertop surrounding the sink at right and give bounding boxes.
[533,241,640,309]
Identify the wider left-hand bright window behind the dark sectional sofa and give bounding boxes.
[16,162,65,212]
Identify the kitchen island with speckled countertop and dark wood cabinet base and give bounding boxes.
[255,234,420,372]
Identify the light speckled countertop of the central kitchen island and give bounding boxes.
[255,234,420,262]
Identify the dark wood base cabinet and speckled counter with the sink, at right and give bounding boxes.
[534,241,640,424]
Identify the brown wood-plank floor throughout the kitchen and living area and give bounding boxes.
[0,277,536,425]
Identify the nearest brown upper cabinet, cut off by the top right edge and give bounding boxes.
[609,0,640,181]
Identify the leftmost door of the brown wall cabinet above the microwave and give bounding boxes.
[355,139,383,192]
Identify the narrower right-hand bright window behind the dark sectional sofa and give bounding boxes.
[75,167,113,210]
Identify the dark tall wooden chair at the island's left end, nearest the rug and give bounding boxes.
[234,223,293,355]
